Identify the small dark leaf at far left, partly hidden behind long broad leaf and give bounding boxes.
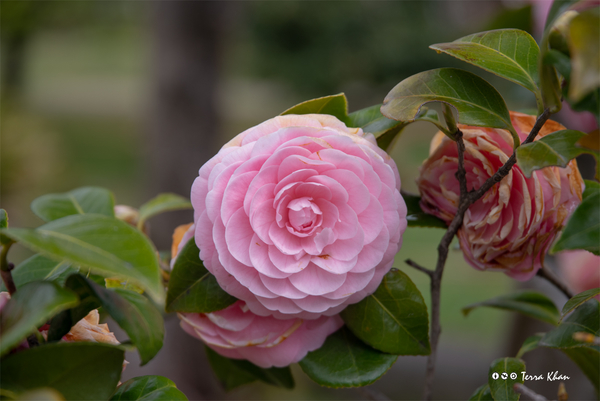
[0,254,79,291]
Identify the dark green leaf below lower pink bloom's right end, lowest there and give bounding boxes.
[300,327,398,388]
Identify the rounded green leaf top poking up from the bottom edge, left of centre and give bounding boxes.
[110,376,187,401]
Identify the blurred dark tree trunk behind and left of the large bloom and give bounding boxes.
[149,1,225,249]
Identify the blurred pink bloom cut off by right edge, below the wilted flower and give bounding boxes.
[556,249,600,301]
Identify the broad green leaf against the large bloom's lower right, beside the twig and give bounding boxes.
[340,269,431,355]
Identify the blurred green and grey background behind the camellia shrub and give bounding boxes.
[0,0,593,400]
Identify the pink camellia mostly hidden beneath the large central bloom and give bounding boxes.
[178,301,344,368]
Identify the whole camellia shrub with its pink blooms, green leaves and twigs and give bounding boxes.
[0,1,600,401]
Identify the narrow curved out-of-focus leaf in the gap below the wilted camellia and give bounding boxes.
[462,291,560,325]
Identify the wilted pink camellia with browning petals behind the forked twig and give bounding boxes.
[417,112,583,281]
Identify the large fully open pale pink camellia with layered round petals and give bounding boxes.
[191,114,406,319]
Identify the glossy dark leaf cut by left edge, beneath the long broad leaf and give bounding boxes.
[0,281,79,355]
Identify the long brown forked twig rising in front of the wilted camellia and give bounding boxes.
[420,109,550,400]
